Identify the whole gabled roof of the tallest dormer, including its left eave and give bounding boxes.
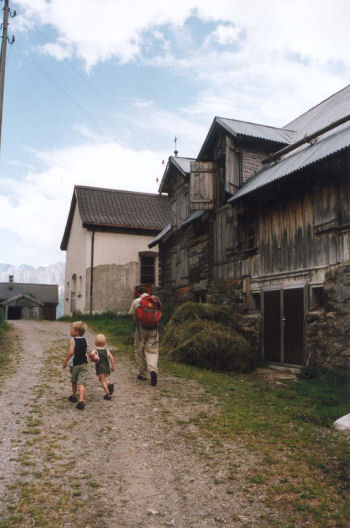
[197,116,295,161]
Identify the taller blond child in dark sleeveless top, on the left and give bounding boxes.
[63,321,88,411]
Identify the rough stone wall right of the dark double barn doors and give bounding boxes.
[306,265,350,369]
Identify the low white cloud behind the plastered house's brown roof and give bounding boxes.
[0,137,170,266]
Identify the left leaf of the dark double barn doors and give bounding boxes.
[263,289,282,363]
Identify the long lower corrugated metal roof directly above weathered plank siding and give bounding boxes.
[229,122,350,202]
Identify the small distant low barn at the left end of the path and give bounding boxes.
[0,275,58,321]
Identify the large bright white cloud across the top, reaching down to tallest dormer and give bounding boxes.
[17,0,350,127]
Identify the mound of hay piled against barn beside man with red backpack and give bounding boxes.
[161,303,255,372]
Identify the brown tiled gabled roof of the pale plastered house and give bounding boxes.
[61,185,170,250]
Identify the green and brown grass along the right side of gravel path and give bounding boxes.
[63,318,350,528]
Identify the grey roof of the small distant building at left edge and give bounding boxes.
[0,282,58,304]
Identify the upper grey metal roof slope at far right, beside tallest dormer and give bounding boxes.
[284,84,350,141]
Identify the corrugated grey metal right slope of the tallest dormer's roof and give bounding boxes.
[216,117,295,145]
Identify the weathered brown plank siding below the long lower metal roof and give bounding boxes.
[214,173,350,286]
